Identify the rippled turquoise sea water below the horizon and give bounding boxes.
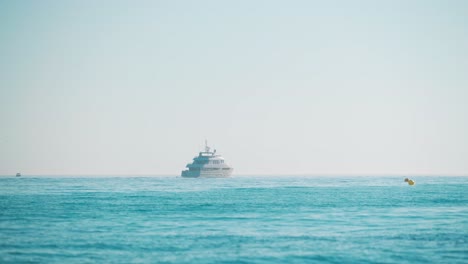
[0,176,468,263]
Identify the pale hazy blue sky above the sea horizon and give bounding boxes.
[0,0,468,175]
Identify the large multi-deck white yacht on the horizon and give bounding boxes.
[181,140,233,178]
